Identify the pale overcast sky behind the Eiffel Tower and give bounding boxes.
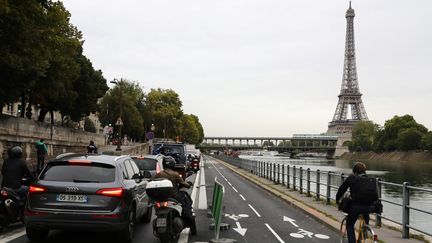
[64,0,432,136]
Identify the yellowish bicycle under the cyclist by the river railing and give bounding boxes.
[339,213,378,243]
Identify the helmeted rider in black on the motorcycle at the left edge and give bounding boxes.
[1,146,35,199]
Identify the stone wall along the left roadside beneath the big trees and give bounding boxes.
[0,115,105,161]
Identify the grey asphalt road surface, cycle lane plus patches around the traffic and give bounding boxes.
[5,157,338,243]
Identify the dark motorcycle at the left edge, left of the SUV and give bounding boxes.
[0,178,30,229]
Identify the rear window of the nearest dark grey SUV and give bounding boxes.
[40,162,115,183]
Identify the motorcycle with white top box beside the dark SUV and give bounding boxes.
[146,174,196,243]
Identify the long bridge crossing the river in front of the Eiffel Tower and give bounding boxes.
[197,134,338,157]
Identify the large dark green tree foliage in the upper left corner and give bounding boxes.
[0,0,108,122]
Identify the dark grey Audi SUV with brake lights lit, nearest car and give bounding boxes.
[24,154,152,242]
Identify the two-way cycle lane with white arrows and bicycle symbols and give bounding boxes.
[189,157,339,243]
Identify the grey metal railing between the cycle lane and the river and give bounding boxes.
[216,156,432,238]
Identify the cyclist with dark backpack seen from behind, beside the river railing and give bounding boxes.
[336,162,378,243]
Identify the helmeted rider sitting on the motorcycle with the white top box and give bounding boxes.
[156,156,193,223]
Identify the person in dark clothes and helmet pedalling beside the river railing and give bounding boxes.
[336,162,377,243]
